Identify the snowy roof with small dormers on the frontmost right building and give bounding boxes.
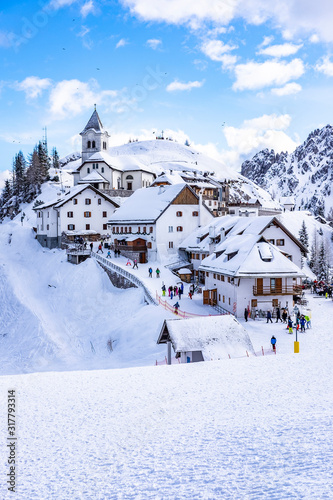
[199,234,305,278]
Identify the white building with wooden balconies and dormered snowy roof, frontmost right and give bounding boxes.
[199,234,305,317]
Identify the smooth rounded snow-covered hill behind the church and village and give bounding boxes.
[61,140,280,208]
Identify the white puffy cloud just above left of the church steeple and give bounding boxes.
[49,80,119,120]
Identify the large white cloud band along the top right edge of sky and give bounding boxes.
[121,0,333,42]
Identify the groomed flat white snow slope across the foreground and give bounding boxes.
[0,292,333,500]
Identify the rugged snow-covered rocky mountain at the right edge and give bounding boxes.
[241,125,333,216]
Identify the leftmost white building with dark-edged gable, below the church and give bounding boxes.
[35,185,119,248]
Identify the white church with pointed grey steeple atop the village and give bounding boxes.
[73,105,156,191]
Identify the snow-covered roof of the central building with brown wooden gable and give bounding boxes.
[109,183,195,223]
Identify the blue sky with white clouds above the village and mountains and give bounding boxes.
[0,0,333,182]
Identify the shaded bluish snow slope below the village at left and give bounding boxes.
[0,220,166,374]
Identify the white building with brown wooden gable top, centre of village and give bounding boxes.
[109,184,213,262]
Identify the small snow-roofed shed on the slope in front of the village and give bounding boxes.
[157,315,254,363]
